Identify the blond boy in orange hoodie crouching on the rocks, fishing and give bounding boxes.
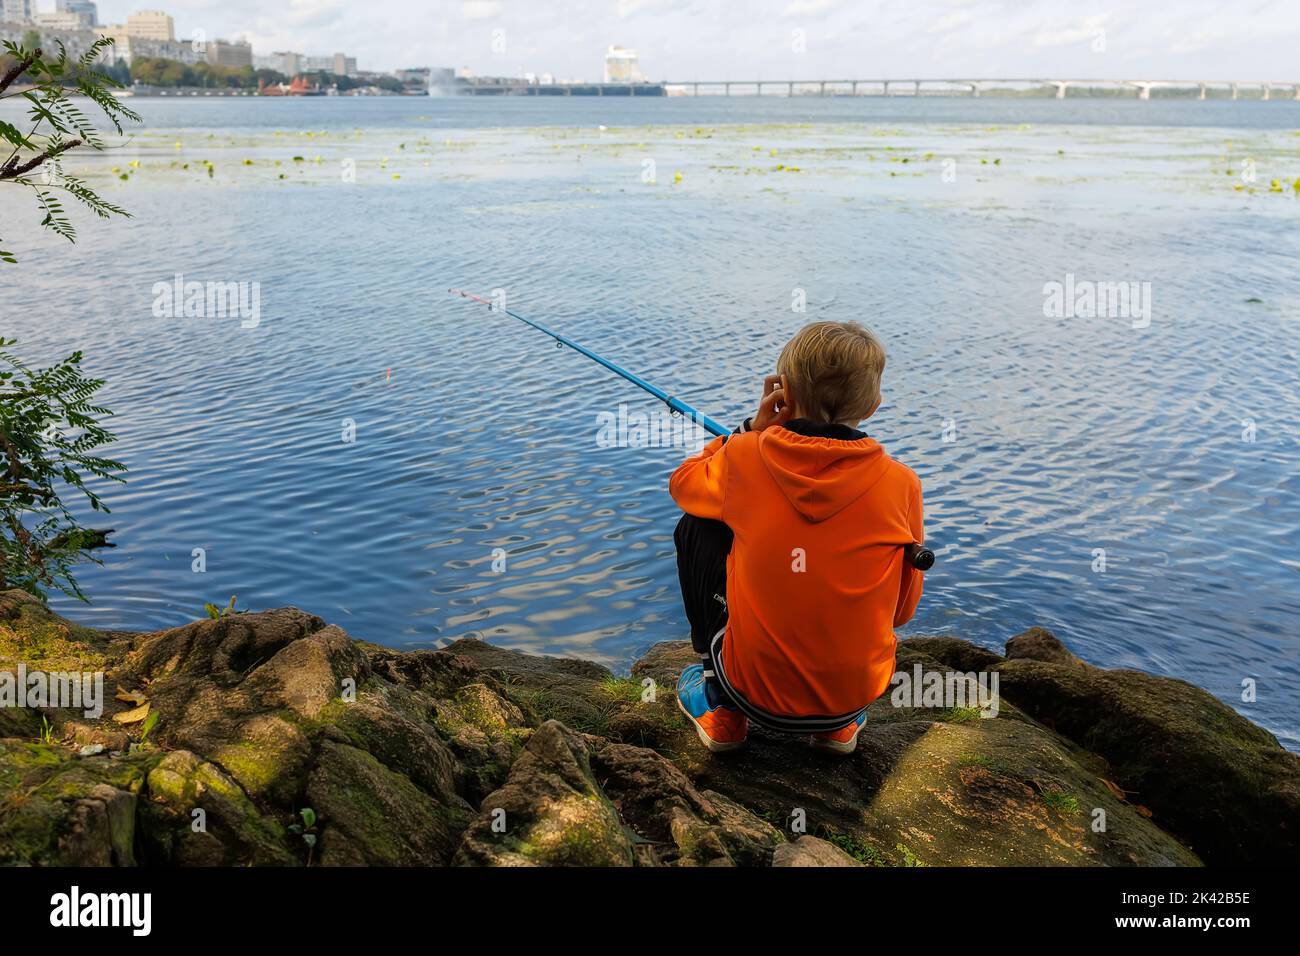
[668,323,923,753]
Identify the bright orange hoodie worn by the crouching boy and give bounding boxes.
[668,421,924,717]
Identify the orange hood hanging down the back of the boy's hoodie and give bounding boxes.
[758,423,889,523]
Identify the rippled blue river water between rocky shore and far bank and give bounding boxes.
[0,100,1300,748]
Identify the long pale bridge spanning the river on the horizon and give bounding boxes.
[663,78,1300,100]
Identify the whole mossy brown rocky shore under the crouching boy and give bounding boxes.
[0,592,1300,866]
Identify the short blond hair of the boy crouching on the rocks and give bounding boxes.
[776,323,885,423]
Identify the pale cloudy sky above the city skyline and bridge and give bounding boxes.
[76,0,1300,82]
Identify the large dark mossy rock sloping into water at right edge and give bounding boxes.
[997,650,1300,865]
